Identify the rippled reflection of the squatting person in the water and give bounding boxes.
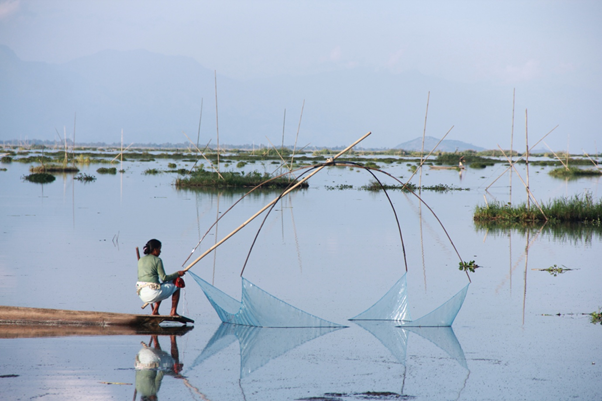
[134,335,183,401]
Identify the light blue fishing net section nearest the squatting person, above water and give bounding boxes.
[189,272,344,327]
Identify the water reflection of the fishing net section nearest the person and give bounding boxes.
[191,323,342,379]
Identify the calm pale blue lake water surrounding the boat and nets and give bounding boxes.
[0,152,602,401]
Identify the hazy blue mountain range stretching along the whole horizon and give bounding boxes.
[0,45,602,151]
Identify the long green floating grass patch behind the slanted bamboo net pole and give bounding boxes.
[175,169,309,189]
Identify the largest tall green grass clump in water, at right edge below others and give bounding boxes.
[474,193,602,227]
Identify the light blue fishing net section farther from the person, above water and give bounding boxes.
[349,274,470,327]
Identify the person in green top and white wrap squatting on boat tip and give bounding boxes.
[136,239,186,316]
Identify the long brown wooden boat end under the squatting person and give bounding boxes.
[0,306,194,330]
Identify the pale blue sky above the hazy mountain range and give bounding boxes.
[0,0,602,151]
